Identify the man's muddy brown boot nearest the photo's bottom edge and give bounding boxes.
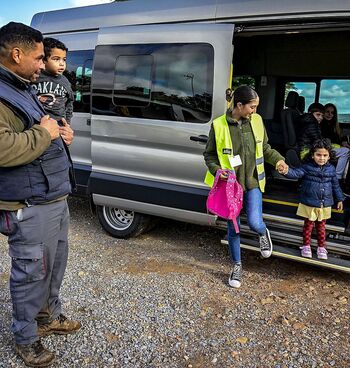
[15,340,56,367]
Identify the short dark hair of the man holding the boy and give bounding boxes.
[0,22,43,57]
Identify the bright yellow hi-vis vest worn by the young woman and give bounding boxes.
[204,114,266,192]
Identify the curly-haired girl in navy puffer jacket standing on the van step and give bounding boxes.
[280,139,345,259]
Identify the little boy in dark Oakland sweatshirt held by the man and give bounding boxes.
[33,38,74,144]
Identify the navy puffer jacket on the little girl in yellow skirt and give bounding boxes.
[286,161,345,208]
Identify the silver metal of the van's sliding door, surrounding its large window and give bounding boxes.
[90,24,234,203]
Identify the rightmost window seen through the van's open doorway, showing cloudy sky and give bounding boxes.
[320,79,350,123]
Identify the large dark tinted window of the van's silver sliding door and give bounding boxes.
[92,43,214,123]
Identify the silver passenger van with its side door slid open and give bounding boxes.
[31,0,350,271]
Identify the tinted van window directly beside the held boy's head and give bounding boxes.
[64,50,94,112]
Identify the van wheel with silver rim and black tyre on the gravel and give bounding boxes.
[96,206,150,239]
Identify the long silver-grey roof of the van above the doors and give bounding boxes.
[31,0,350,34]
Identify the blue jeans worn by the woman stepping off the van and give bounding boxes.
[227,188,266,263]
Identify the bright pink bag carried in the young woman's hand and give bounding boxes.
[207,169,243,233]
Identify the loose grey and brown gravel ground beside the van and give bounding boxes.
[0,198,350,368]
